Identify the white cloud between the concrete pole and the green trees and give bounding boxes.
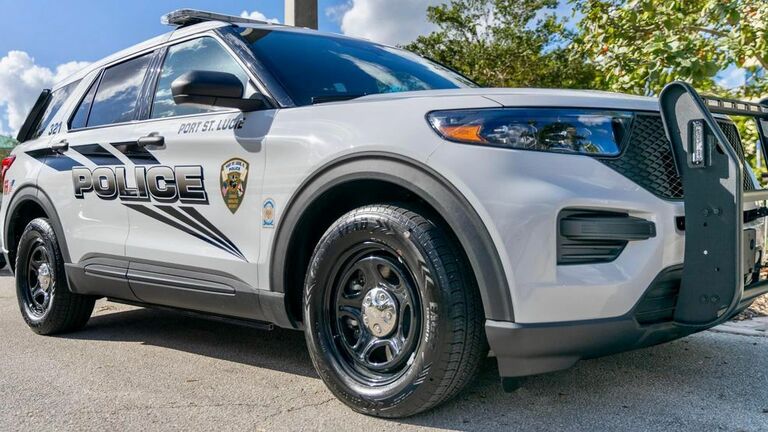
[326,0,447,45]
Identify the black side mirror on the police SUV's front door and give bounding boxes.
[171,70,266,111]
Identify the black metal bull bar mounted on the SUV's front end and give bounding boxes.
[659,82,768,328]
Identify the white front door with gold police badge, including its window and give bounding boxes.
[124,35,273,317]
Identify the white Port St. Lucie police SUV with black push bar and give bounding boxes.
[0,10,768,417]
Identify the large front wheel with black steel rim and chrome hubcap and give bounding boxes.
[304,205,488,418]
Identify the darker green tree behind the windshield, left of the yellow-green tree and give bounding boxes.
[405,0,595,88]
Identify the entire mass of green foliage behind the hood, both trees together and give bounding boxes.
[406,0,768,179]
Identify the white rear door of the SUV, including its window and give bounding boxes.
[39,53,154,299]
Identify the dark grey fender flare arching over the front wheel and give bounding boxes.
[270,152,514,321]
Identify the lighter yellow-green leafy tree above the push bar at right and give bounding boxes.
[570,0,768,97]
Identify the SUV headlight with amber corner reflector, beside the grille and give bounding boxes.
[427,108,633,156]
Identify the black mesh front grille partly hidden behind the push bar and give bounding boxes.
[602,113,755,200]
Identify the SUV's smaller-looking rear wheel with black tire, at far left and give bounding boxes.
[16,218,95,335]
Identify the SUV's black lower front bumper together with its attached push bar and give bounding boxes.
[486,83,768,377]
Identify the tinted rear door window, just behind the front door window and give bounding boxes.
[88,54,151,127]
